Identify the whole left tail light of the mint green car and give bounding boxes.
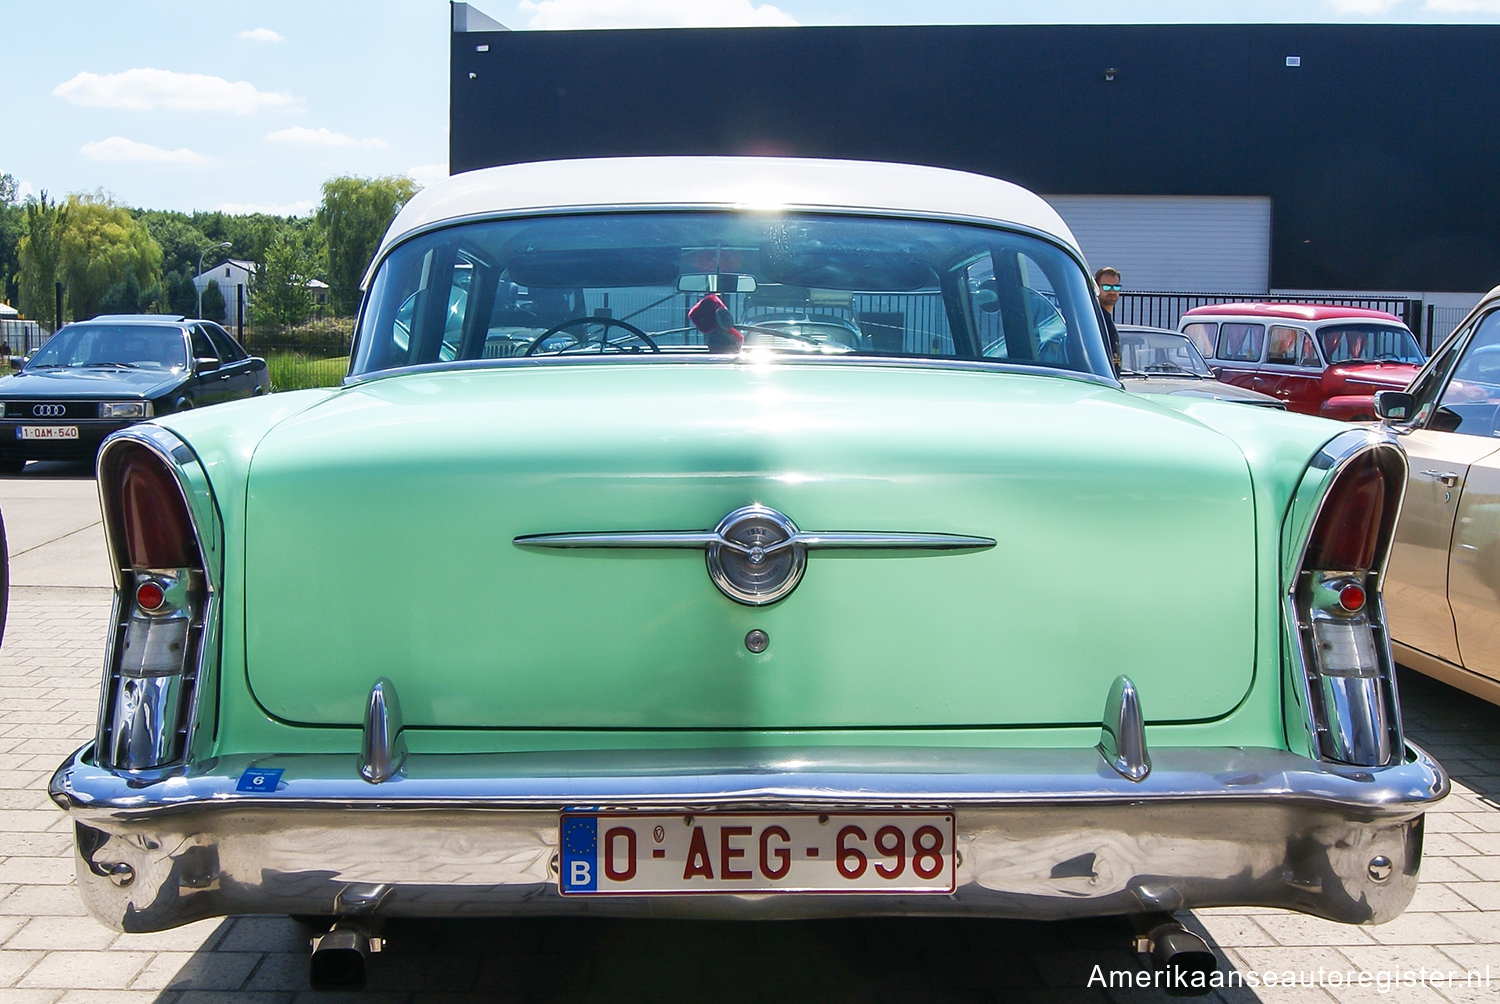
[95,438,207,770]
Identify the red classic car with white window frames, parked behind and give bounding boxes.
[1178,303,1425,422]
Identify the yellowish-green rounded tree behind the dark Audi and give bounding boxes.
[62,194,162,318]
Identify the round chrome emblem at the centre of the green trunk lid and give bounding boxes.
[708,506,807,606]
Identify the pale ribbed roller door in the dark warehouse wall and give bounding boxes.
[1046,195,1271,293]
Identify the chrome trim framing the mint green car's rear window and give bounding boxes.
[343,203,1122,387]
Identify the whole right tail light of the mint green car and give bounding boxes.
[1290,432,1406,767]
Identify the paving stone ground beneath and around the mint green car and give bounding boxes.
[0,471,1500,1004]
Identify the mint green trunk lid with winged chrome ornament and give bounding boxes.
[245,363,1256,729]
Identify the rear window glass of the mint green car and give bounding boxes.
[351,212,1110,375]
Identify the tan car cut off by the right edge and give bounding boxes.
[1377,287,1500,704]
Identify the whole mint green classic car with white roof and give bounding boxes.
[51,158,1448,981]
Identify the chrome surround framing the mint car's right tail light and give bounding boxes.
[1281,426,1409,762]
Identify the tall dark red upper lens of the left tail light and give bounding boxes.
[99,444,203,569]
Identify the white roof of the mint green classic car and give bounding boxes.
[366,158,1082,282]
